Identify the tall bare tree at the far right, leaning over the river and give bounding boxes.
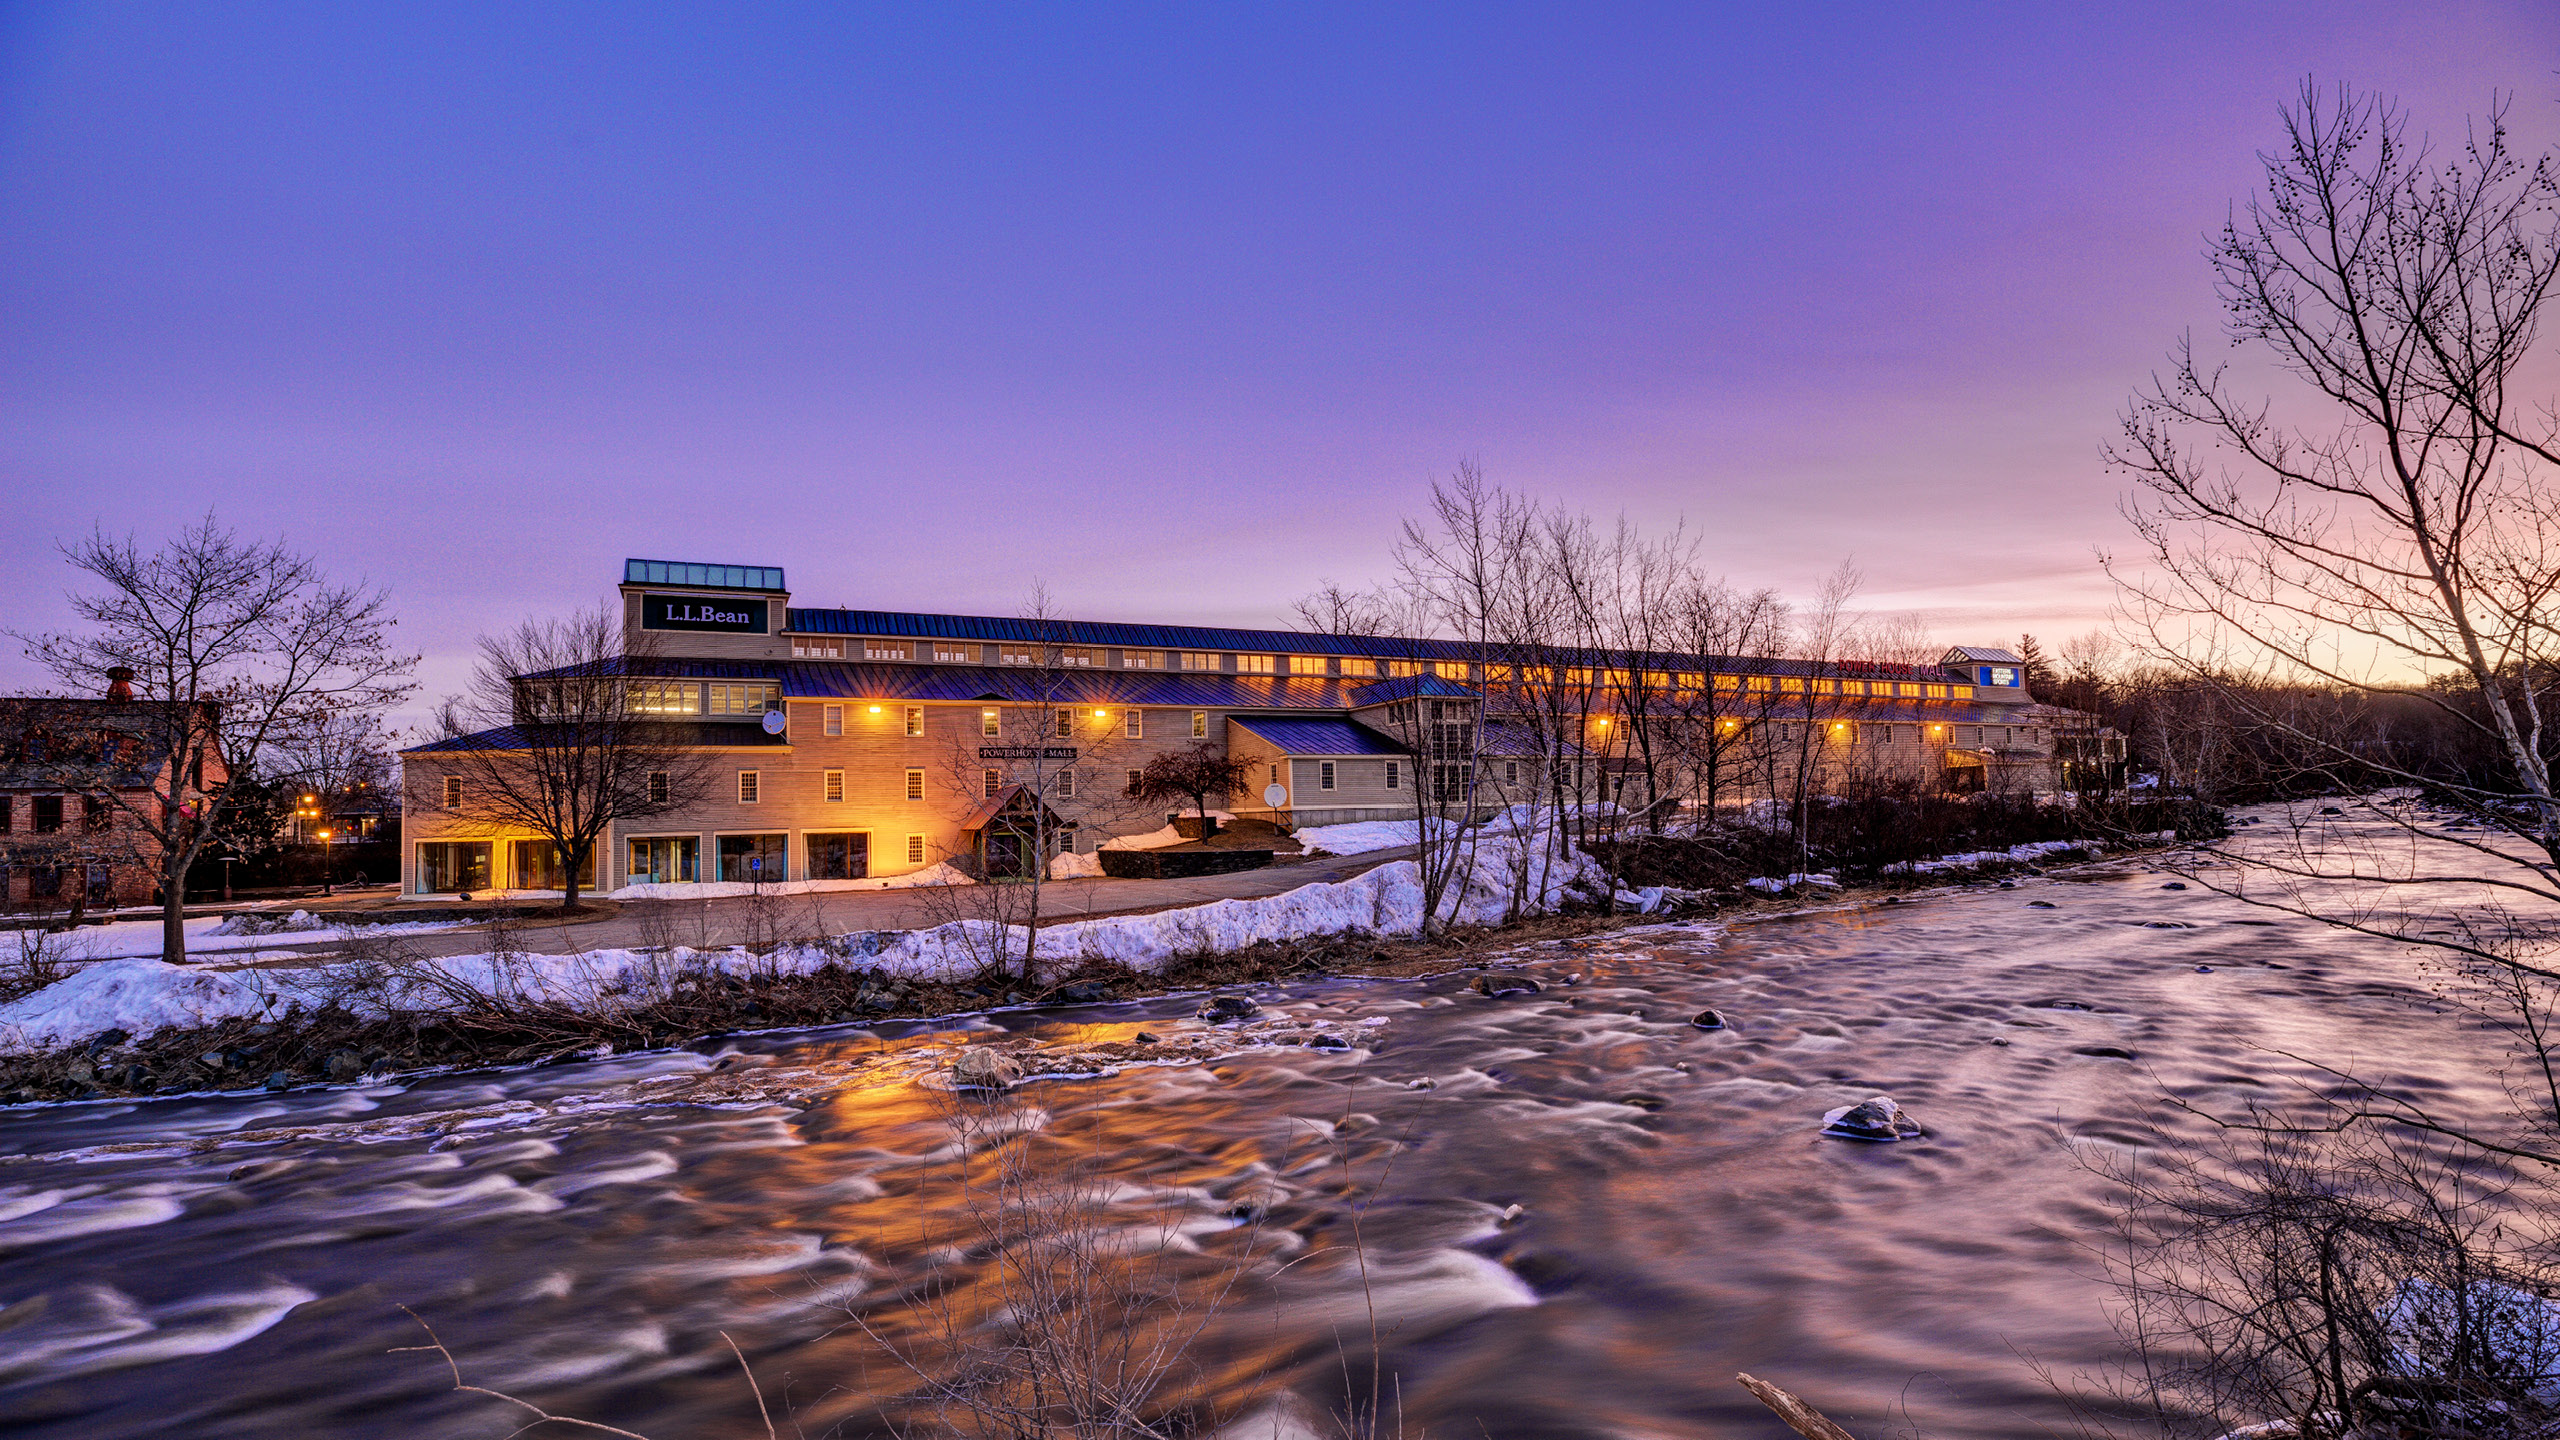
[2107,85,2560,1142]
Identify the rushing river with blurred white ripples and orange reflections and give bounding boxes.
[0,869,2496,1440]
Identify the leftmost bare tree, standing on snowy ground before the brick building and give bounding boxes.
[10,515,417,963]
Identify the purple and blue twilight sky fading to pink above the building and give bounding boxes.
[0,0,2560,712]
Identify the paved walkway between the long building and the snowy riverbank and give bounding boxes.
[230,846,1413,963]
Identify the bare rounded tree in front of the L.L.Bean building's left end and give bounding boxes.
[435,607,717,910]
